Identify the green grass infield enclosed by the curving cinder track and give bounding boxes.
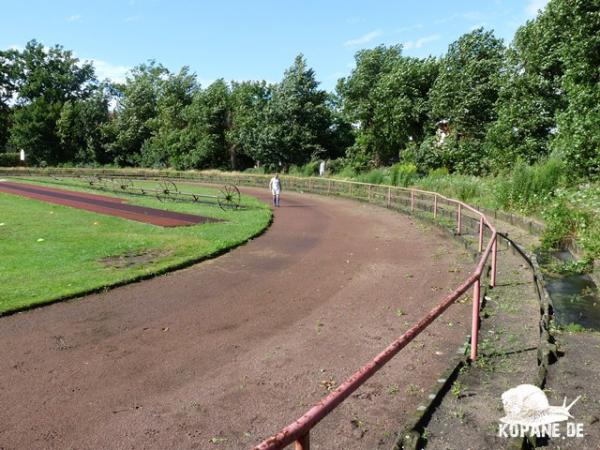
[0,178,271,314]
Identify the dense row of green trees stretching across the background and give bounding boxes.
[0,0,600,178]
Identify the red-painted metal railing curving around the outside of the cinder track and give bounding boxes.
[0,169,497,450]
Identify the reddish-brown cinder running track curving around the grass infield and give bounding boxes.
[0,190,472,450]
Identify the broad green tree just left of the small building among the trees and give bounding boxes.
[337,46,438,168]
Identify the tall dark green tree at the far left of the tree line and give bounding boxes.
[9,40,96,164]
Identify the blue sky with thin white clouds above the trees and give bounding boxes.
[0,0,548,90]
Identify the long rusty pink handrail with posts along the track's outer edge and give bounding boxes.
[0,169,498,450]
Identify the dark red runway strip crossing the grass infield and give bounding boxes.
[0,181,217,227]
